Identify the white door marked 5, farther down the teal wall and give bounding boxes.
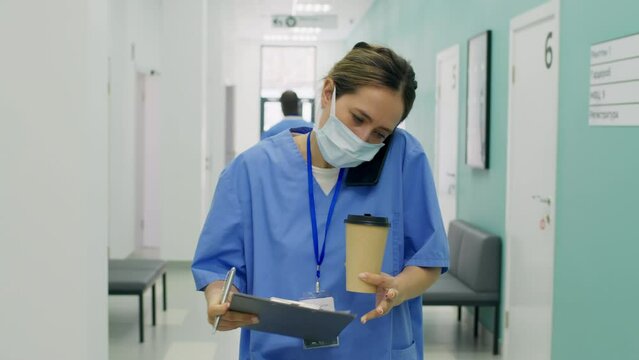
[435,45,459,231]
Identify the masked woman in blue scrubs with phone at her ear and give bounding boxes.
[192,43,448,360]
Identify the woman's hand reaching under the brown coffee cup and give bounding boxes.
[359,273,404,324]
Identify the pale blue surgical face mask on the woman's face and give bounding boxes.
[316,88,384,168]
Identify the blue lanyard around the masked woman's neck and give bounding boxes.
[306,133,344,293]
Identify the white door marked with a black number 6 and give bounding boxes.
[504,2,559,359]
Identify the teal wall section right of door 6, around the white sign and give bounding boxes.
[553,0,639,359]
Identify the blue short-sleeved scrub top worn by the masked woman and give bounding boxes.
[192,129,448,360]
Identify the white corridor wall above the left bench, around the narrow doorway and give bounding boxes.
[109,0,225,260]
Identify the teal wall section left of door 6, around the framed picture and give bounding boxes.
[348,0,545,344]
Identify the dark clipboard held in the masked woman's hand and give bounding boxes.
[229,293,355,341]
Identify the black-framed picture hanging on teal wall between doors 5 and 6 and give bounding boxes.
[466,30,490,169]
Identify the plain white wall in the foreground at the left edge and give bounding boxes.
[0,0,108,360]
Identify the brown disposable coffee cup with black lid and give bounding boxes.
[344,214,390,293]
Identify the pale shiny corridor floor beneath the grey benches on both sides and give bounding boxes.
[109,252,500,360]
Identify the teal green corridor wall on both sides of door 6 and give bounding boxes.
[347,0,639,359]
